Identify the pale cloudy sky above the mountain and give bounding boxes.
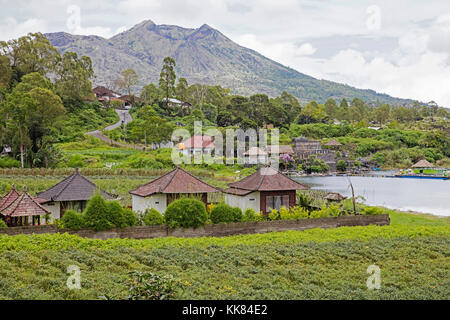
[0,0,450,107]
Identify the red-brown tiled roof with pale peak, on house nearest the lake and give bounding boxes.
[224,167,309,194]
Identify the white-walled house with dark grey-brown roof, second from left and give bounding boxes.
[36,169,114,220]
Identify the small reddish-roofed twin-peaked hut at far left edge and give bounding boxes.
[0,188,50,227]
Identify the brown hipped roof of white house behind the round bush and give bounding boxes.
[129,167,218,197]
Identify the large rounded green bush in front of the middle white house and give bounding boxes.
[164,198,208,228]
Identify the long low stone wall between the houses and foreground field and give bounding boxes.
[0,214,390,239]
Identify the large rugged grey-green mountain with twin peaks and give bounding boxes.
[45,20,412,104]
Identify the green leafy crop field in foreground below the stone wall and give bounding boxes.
[0,213,450,299]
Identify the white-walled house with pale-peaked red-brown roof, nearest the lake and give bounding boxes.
[223,167,309,214]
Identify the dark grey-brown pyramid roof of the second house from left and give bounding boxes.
[37,169,114,203]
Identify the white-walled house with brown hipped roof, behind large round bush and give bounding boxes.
[129,167,219,213]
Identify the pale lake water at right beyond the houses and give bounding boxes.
[294,172,450,216]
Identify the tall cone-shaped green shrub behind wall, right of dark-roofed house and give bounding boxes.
[85,194,114,231]
